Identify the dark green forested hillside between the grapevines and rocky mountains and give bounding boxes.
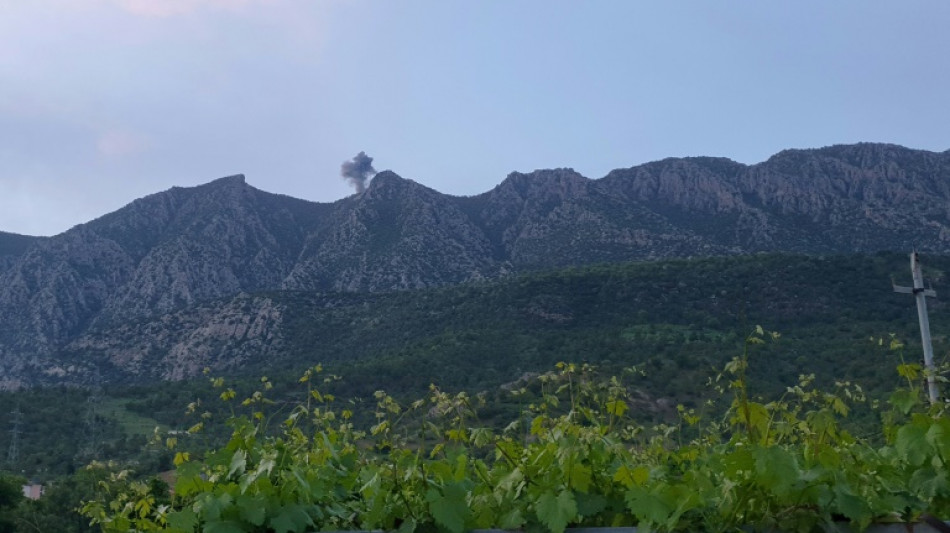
[0,253,950,480]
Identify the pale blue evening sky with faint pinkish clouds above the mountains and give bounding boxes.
[0,0,950,235]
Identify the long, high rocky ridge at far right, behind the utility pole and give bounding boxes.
[600,144,950,253]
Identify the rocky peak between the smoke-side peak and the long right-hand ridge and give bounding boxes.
[473,169,728,269]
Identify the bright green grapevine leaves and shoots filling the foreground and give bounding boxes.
[83,328,950,533]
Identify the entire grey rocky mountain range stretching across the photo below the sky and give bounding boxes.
[0,144,950,387]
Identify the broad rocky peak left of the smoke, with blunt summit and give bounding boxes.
[97,176,326,320]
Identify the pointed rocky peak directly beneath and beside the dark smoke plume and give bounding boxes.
[283,171,499,291]
